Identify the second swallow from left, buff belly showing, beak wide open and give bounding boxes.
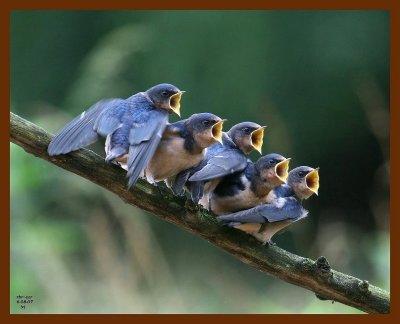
[145,113,225,184]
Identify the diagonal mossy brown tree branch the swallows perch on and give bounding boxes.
[10,113,390,313]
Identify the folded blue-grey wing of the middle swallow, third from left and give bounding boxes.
[189,149,247,181]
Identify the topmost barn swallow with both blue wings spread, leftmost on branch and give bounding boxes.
[47,83,184,188]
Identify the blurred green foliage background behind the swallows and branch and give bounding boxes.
[10,11,389,313]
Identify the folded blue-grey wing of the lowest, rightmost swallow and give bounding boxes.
[218,197,308,224]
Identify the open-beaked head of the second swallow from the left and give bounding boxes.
[186,113,226,148]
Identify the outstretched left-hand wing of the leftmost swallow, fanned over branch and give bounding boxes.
[47,99,126,156]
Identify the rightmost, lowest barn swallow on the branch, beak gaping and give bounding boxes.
[218,166,319,244]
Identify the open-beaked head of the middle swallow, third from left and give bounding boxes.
[228,122,266,154]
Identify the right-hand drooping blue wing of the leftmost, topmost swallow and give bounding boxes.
[127,110,168,188]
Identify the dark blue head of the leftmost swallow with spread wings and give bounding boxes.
[146,83,185,116]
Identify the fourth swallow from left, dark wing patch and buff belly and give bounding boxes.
[210,153,290,215]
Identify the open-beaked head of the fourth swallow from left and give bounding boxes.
[255,153,290,189]
